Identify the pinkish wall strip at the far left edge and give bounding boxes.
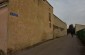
[0,7,8,53]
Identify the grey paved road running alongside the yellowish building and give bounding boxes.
[13,36,83,55]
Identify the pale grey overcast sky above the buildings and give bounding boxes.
[48,0,85,25]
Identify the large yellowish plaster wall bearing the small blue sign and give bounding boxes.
[8,0,53,50]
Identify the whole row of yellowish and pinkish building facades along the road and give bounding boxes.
[0,0,67,52]
